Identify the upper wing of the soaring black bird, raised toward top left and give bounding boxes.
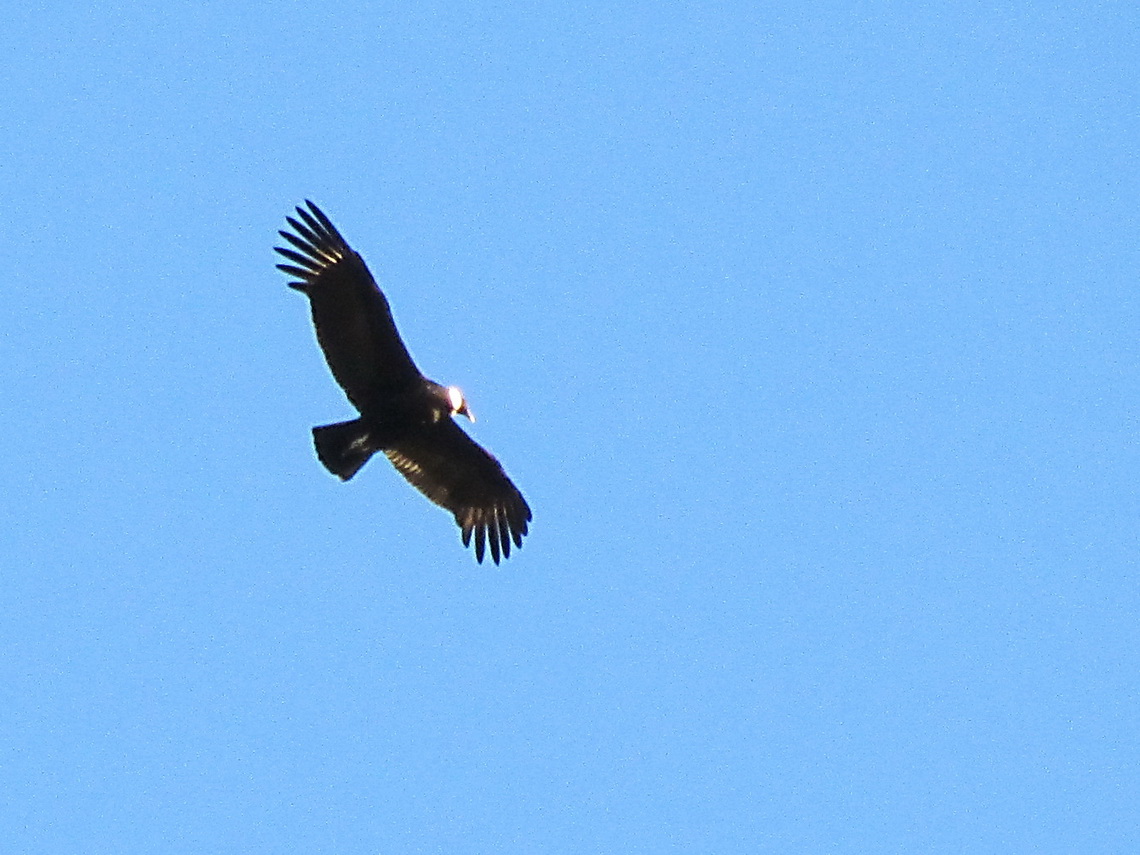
[275,200,421,412]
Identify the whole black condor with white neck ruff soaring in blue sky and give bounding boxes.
[275,201,531,564]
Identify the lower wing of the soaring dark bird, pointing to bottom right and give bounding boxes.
[384,418,531,564]
